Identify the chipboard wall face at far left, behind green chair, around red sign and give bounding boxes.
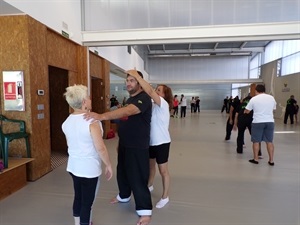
[0,16,31,159]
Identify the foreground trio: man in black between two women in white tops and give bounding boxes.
[62,70,173,225]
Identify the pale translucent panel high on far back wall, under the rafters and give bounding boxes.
[147,56,249,81]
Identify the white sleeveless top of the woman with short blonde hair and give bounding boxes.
[62,114,103,178]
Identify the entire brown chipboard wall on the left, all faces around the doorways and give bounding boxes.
[0,15,110,180]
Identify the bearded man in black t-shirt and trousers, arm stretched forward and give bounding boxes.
[85,71,152,225]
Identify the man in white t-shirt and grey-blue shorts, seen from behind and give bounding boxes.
[245,84,277,166]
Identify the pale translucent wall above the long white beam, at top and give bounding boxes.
[85,0,299,30]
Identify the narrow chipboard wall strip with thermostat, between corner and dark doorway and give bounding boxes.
[27,17,51,180]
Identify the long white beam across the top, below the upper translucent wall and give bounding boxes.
[82,21,300,47]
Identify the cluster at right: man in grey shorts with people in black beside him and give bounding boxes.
[225,84,276,166]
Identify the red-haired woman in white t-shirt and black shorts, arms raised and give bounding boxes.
[127,70,173,208]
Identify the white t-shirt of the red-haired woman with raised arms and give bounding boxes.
[150,97,171,146]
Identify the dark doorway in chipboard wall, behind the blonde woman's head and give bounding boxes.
[49,66,69,155]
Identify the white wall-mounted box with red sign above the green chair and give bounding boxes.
[2,71,25,111]
